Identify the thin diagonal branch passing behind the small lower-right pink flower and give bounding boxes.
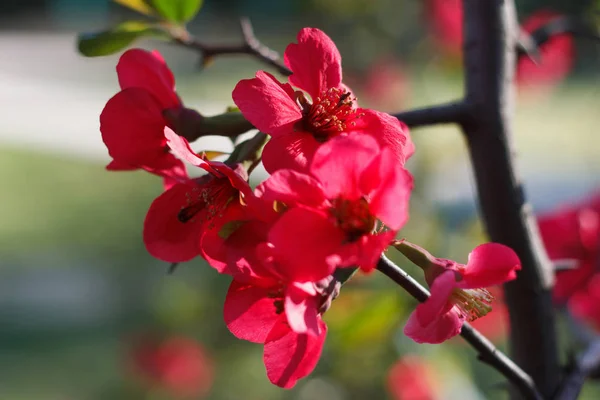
[377,255,543,400]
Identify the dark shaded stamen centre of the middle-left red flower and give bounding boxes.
[177,175,238,227]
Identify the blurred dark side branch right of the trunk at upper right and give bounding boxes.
[517,17,600,60]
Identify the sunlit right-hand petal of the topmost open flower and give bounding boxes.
[351,108,415,165]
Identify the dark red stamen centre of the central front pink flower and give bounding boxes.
[330,197,376,242]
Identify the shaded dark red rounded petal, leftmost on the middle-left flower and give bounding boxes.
[144,182,203,262]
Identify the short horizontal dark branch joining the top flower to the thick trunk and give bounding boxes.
[394,101,468,128]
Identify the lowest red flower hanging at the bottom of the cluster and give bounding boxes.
[223,231,333,388]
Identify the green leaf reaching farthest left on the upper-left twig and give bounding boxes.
[77,21,168,57]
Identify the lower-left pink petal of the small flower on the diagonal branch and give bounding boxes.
[404,307,464,344]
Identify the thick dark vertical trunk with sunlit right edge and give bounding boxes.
[463,0,561,398]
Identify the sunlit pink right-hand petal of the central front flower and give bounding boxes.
[360,148,413,230]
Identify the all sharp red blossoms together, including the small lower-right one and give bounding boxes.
[100,28,518,388]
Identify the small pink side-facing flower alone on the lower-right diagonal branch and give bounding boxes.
[404,243,521,343]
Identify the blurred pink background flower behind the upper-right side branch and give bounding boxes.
[517,10,575,85]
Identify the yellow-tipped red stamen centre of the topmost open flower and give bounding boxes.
[297,88,360,141]
